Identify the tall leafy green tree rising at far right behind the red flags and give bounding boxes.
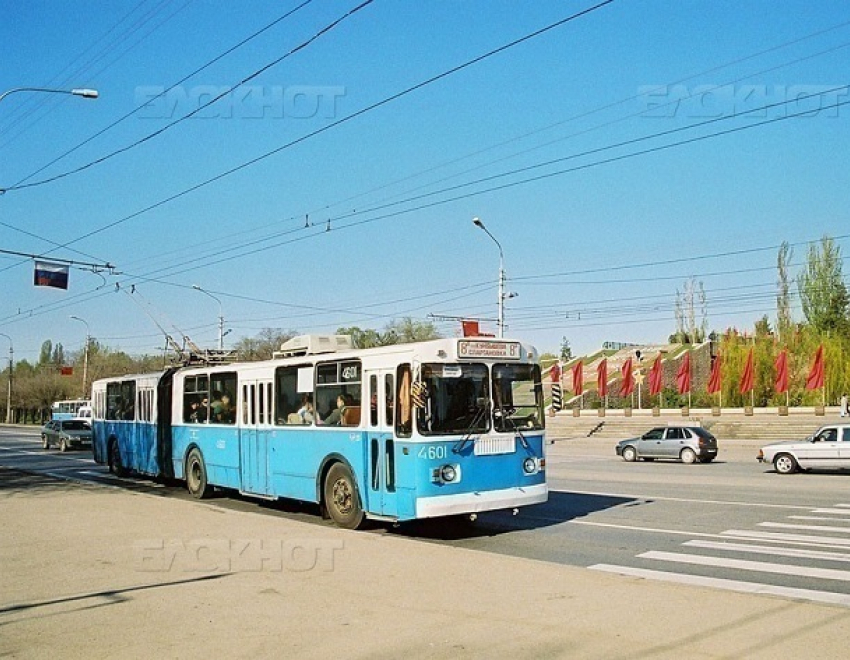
[797,236,850,333]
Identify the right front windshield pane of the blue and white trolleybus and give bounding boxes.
[493,364,544,432]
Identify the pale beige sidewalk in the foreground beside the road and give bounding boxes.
[0,468,850,660]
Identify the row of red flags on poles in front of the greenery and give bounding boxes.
[558,345,824,396]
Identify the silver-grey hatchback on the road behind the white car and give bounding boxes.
[616,425,717,463]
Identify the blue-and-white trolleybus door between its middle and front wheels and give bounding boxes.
[239,380,272,495]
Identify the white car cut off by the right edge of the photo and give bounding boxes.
[756,424,850,474]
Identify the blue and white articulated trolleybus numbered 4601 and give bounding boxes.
[92,335,548,528]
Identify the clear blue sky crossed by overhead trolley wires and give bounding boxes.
[0,0,850,361]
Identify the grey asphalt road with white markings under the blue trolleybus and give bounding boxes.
[0,427,850,606]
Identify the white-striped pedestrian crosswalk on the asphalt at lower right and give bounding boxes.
[590,504,850,607]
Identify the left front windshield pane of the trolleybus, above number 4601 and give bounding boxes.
[416,363,490,435]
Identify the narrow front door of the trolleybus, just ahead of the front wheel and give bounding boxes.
[366,369,398,516]
